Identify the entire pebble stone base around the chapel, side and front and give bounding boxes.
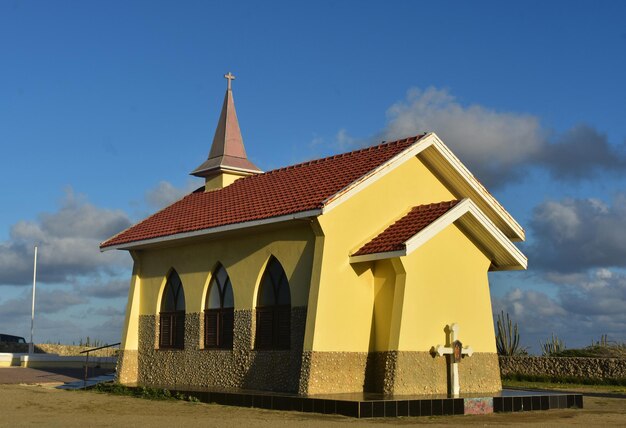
[118,307,502,395]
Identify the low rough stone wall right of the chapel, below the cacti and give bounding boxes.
[500,356,626,379]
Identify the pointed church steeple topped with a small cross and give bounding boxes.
[191,73,263,191]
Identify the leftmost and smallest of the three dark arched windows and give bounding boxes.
[159,270,185,349]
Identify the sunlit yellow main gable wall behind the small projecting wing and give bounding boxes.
[304,157,455,352]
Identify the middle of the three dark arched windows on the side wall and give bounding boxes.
[204,265,235,349]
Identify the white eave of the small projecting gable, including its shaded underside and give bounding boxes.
[350,198,528,270]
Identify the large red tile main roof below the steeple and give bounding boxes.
[100,134,425,248]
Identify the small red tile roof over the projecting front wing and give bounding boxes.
[353,200,459,256]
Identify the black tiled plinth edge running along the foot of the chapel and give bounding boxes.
[141,389,583,418]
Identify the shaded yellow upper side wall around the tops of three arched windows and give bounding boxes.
[134,222,314,315]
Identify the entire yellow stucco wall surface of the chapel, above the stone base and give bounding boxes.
[123,152,502,360]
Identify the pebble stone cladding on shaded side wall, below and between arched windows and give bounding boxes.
[132,307,306,392]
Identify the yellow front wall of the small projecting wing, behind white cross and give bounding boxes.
[392,224,496,352]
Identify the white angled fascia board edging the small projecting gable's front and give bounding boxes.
[405,198,528,269]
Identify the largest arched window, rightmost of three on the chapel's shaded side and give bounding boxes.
[254,256,291,349]
